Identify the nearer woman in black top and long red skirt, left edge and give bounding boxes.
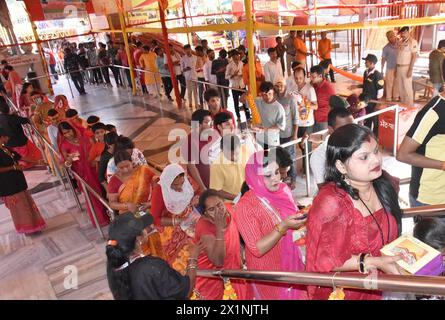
[0,128,45,234]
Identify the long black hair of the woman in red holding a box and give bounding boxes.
[325,124,402,234]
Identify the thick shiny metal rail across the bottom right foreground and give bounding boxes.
[197,270,445,296]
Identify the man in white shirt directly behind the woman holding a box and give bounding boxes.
[309,108,354,189]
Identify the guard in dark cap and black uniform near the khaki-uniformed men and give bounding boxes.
[359,54,385,136]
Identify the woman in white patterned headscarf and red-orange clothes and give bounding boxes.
[151,164,200,272]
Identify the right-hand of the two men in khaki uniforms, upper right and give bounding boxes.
[396,27,418,106]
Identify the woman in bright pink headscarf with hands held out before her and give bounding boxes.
[235,151,307,300]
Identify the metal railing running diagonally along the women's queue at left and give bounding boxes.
[5,97,114,239]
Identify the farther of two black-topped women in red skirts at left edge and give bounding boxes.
[0,96,43,169]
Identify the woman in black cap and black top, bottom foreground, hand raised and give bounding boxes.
[106,211,200,300]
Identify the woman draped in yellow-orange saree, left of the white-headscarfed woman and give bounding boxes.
[108,150,165,259]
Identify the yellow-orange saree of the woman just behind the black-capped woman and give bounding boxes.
[119,165,165,260]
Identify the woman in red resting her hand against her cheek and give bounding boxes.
[194,189,251,300]
